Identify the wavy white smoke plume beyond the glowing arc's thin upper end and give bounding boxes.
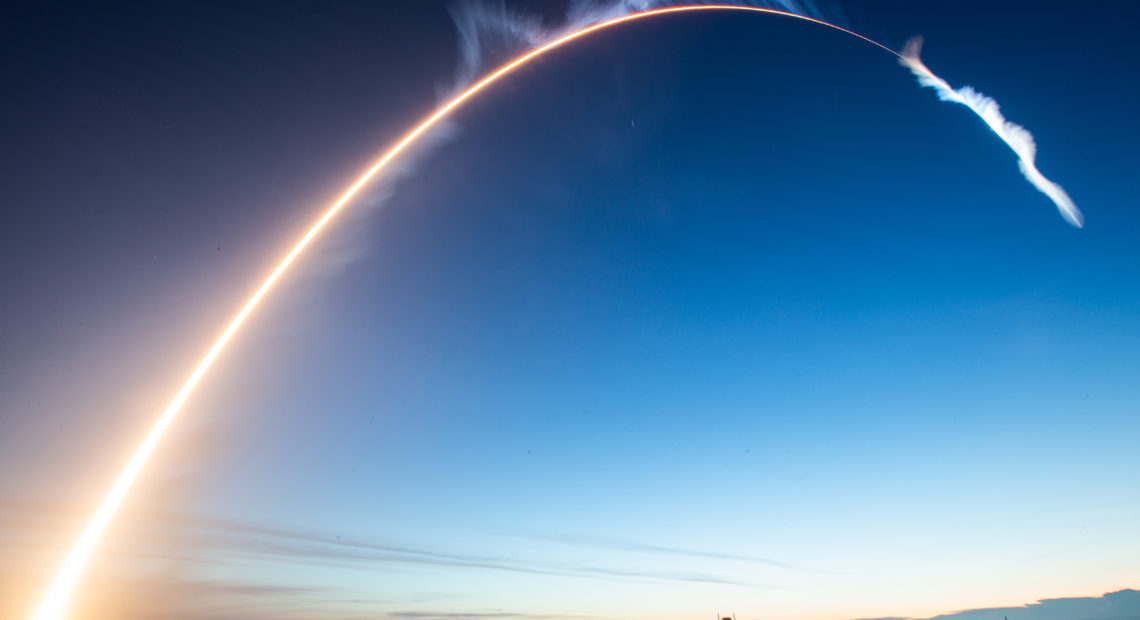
[898,36,1084,228]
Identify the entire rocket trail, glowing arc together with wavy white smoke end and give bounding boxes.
[32,5,1081,620]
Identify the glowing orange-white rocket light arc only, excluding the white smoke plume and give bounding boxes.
[32,5,901,620]
